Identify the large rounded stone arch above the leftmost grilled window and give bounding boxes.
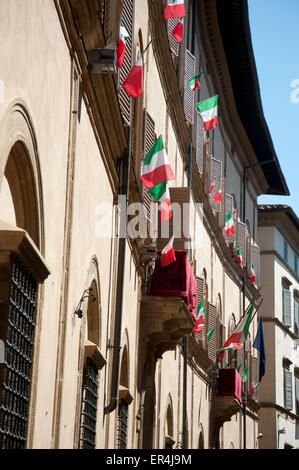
[0,100,44,254]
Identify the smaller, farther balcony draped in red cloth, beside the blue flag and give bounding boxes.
[213,367,242,427]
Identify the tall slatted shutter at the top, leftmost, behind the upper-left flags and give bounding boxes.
[118,0,134,125]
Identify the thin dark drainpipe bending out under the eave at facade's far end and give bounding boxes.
[242,156,275,449]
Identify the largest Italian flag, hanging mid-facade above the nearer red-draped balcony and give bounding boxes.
[141,136,175,190]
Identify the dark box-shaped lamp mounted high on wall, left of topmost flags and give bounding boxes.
[86,42,116,74]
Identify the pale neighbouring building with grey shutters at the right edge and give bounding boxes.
[258,205,299,449]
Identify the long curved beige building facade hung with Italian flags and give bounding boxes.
[0,0,288,449]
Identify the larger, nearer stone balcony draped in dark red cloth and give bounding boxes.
[140,250,197,362]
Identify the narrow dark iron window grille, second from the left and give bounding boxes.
[80,358,98,449]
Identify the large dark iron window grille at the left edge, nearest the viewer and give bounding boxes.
[0,256,37,449]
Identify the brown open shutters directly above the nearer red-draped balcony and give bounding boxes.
[157,187,191,250]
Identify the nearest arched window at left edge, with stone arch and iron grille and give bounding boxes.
[0,103,49,449]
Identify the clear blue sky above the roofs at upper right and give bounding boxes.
[248,0,299,216]
